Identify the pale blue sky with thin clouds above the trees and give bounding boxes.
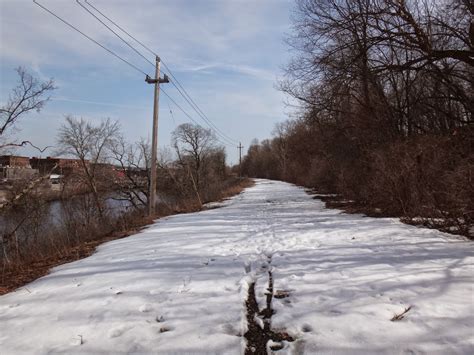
[0,0,293,163]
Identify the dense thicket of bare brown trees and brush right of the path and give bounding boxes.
[243,0,474,238]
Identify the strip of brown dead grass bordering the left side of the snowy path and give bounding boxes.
[0,179,254,295]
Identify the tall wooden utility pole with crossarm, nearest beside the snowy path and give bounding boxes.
[145,56,170,216]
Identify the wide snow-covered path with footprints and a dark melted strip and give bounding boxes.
[0,180,474,354]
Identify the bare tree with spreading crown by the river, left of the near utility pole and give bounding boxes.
[58,116,120,217]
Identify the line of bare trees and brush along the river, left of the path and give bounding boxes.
[0,68,242,286]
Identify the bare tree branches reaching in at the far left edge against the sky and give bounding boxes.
[0,67,56,149]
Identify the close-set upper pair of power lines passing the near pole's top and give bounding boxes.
[82,0,237,144]
